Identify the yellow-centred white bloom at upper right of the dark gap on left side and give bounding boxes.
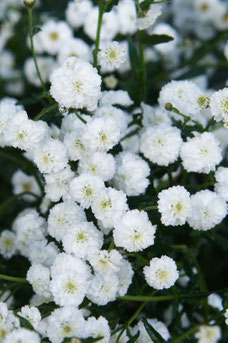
[33,138,68,173]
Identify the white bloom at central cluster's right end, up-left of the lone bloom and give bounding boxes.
[113,210,156,252]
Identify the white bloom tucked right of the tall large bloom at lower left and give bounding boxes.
[86,273,119,306]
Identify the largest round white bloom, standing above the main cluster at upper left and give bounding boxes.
[50,57,101,111]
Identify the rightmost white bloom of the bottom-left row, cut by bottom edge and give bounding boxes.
[87,316,111,343]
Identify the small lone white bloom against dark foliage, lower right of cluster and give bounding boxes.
[143,256,179,289]
